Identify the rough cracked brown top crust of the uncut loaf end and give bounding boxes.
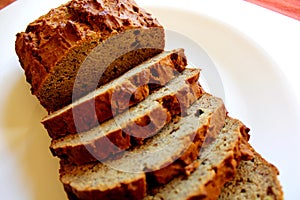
[16,0,161,90]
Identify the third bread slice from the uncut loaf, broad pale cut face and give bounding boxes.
[60,94,226,200]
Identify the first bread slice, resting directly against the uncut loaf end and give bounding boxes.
[42,49,187,139]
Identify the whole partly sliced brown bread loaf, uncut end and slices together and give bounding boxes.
[16,0,283,200]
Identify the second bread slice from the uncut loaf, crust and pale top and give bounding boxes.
[50,69,202,164]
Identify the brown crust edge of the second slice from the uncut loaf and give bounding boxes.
[50,71,203,165]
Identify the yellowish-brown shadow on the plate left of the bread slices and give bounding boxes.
[3,76,66,200]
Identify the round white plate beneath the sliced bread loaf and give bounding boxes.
[0,0,300,200]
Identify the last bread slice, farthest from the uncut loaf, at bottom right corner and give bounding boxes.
[219,144,284,200]
